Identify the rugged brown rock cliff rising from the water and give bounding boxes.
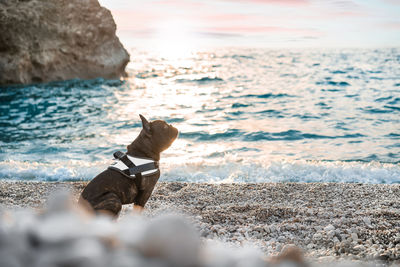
[0,0,129,85]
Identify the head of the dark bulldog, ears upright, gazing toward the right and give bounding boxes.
[128,115,178,157]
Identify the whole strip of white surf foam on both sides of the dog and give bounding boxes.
[0,160,400,184]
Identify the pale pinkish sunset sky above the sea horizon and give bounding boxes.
[99,0,400,50]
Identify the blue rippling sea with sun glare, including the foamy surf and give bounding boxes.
[0,47,400,184]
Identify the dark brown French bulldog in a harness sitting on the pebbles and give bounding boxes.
[78,115,178,218]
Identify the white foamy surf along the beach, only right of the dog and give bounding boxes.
[163,161,400,184]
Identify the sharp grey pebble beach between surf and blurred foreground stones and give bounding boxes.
[0,180,400,263]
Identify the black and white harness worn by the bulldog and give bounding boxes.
[108,151,160,179]
